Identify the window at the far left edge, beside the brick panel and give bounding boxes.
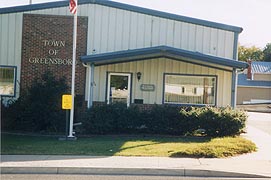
[0,66,16,96]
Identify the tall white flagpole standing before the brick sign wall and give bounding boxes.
[68,0,78,138]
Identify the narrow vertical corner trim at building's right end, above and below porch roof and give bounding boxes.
[231,32,239,109]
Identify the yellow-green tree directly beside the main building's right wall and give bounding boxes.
[238,45,264,61]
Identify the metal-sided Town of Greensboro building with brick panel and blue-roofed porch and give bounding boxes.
[0,0,248,107]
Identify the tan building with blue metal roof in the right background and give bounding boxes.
[237,61,271,104]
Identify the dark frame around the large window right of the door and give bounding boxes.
[162,73,218,107]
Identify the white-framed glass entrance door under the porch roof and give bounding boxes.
[107,73,131,106]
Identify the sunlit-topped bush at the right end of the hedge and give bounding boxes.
[180,107,247,137]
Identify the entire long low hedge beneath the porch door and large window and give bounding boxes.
[79,104,247,137]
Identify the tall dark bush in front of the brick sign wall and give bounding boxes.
[3,72,67,132]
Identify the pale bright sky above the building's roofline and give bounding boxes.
[0,0,271,48]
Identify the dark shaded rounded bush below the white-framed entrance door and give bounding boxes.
[79,103,144,134]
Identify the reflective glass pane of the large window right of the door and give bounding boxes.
[164,74,217,105]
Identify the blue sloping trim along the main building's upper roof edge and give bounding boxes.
[0,0,243,33]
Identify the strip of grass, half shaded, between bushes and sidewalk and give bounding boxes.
[1,134,256,158]
